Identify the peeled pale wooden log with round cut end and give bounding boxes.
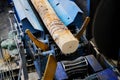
[31,0,79,54]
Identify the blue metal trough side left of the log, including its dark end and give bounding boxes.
[13,0,43,33]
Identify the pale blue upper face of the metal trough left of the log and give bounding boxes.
[13,0,43,31]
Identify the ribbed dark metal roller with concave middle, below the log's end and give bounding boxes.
[61,57,88,76]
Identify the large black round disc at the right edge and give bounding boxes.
[93,0,120,59]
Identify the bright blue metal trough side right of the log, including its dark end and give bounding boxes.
[48,0,83,27]
